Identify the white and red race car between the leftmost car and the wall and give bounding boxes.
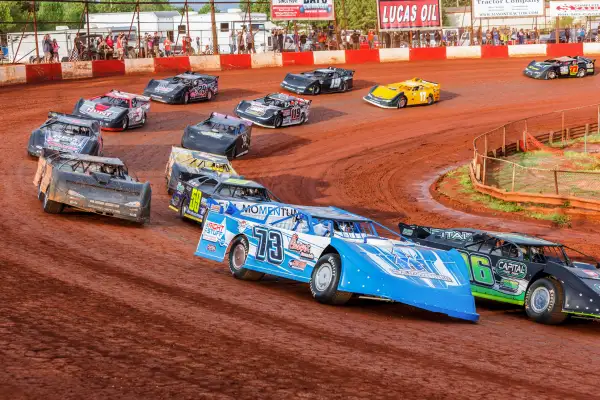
[73,90,150,131]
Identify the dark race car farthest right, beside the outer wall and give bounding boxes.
[523,56,596,79]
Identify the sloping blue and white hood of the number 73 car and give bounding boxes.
[332,238,479,321]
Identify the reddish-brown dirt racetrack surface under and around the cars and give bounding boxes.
[0,60,600,399]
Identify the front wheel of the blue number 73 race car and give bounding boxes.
[309,253,353,305]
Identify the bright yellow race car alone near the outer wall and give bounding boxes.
[363,78,440,108]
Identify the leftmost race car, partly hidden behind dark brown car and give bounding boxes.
[27,111,102,157]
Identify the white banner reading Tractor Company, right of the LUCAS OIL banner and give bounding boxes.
[473,0,544,19]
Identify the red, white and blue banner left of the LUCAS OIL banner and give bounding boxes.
[271,0,335,21]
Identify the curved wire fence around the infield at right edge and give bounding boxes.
[471,105,600,203]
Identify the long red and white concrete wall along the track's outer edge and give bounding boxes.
[0,43,600,86]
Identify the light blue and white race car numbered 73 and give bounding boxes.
[195,202,479,321]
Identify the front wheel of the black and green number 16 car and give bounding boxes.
[525,277,568,325]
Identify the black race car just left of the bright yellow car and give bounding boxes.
[281,67,354,95]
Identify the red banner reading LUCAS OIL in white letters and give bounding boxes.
[377,0,442,30]
